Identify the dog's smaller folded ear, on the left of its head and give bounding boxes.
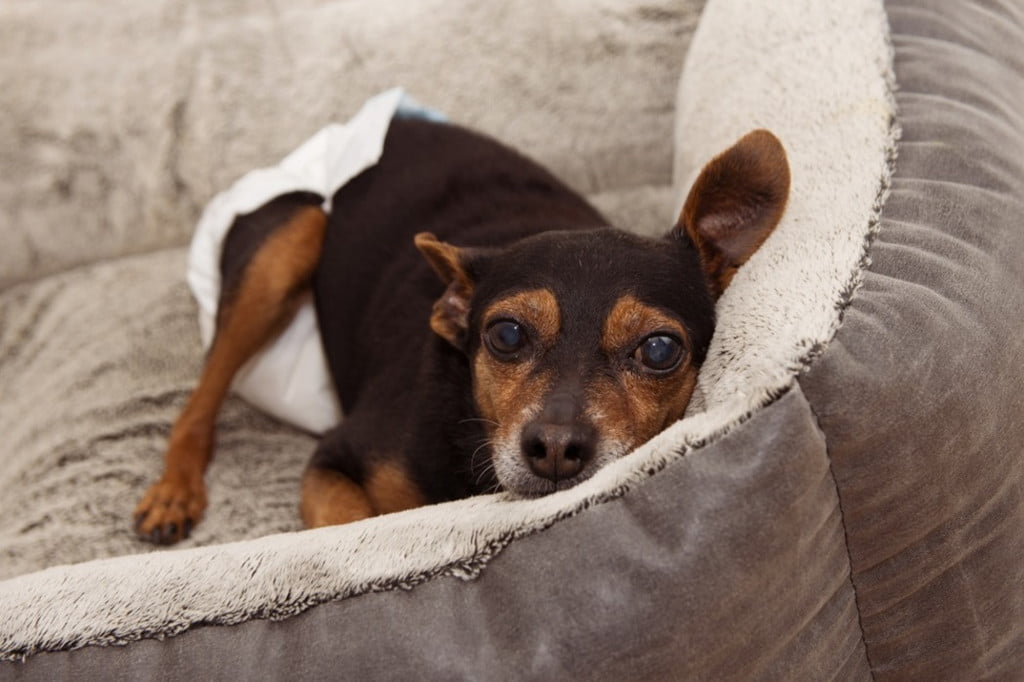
[413,232,474,350]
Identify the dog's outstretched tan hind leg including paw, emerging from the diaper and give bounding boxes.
[134,200,327,544]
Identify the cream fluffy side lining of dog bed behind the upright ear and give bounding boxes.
[675,0,898,413]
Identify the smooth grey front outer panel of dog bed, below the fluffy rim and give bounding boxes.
[8,388,870,681]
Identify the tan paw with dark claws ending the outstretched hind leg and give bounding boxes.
[134,476,206,545]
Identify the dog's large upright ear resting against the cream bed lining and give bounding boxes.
[674,130,790,298]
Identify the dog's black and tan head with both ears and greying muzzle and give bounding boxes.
[416,130,790,495]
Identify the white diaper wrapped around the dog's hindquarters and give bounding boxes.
[188,88,443,433]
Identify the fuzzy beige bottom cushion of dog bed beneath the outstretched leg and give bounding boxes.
[0,249,314,579]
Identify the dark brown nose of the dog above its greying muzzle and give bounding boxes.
[522,421,597,482]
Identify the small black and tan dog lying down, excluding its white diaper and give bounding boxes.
[135,119,790,543]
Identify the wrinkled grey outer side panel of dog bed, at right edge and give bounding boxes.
[801,0,1024,680]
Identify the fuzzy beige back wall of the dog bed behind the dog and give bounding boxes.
[0,0,702,289]
